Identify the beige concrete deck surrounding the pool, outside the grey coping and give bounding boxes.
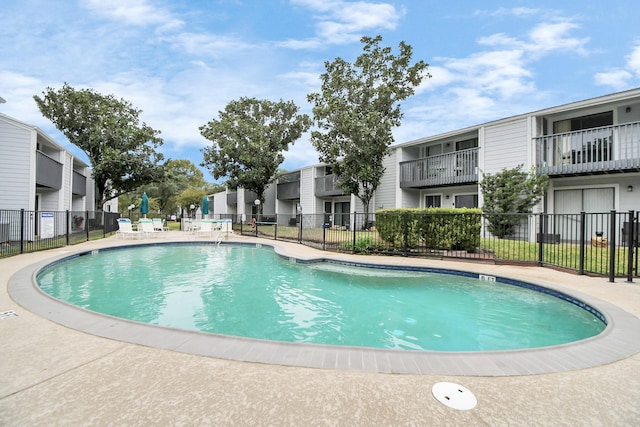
[0,232,640,426]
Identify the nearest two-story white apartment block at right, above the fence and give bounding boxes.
[390,89,640,217]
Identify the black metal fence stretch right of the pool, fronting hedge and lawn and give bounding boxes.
[234,211,640,281]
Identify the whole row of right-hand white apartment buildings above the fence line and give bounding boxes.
[212,88,640,225]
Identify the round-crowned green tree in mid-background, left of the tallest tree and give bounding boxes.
[200,97,311,211]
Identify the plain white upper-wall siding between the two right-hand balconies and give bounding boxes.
[479,117,531,173]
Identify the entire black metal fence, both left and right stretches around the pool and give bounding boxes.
[0,210,640,281]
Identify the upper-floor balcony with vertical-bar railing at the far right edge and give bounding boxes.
[534,122,640,176]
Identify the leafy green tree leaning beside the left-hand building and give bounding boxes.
[33,83,164,206]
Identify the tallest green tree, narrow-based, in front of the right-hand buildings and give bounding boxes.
[307,36,431,226]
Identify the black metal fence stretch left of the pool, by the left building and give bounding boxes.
[0,209,120,258]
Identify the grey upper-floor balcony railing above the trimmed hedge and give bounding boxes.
[400,147,478,188]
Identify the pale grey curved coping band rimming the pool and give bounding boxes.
[8,240,640,376]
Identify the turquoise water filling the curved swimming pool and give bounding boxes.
[37,244,606,351]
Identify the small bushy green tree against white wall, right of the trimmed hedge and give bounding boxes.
[480,164,549,239]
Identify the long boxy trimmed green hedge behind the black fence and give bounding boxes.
[376,208,482,252]
